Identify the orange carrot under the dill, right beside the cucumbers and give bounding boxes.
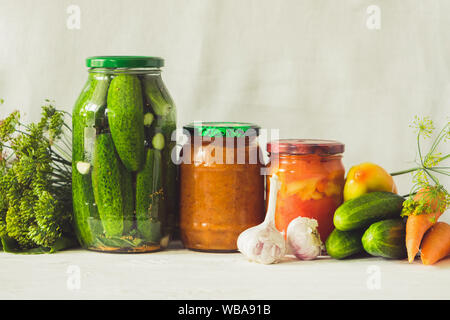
[405,190,443,263]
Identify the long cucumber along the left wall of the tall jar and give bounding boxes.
[72,73,110,247]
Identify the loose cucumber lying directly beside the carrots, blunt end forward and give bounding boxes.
[362,219,407,259]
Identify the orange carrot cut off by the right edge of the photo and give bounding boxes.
[420,222,450,265]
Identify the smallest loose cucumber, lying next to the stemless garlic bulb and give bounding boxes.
[325,229,364,259]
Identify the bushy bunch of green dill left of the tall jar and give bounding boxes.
[0,103,73,250]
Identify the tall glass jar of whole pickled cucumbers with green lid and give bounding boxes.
[72,56,178,252]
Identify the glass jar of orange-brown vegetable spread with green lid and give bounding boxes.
[180,122,264,252]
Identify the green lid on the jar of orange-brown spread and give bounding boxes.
[183,122,260,138]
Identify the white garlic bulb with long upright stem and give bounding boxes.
[237,174,286,264]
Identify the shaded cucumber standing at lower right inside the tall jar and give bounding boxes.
[136,149,164,242]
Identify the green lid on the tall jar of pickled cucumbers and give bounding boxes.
[86,56,164,68]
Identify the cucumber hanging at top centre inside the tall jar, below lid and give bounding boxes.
[107,74,145,171]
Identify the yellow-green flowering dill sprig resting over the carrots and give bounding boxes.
[391,116,450,216]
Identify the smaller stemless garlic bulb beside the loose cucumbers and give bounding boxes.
[287,217,323,260]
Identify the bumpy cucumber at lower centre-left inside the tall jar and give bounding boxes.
[92,133,133,237]
